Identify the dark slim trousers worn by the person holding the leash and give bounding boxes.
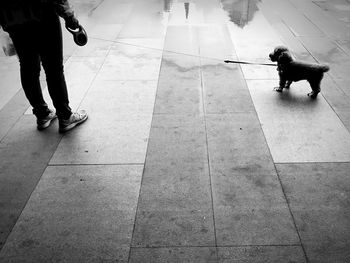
[8,8,72,119]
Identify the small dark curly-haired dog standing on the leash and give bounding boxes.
[269,46,329,98]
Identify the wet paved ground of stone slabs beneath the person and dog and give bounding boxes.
[0,0,350,263]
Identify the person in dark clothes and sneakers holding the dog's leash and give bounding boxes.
[0,0,87,132]
